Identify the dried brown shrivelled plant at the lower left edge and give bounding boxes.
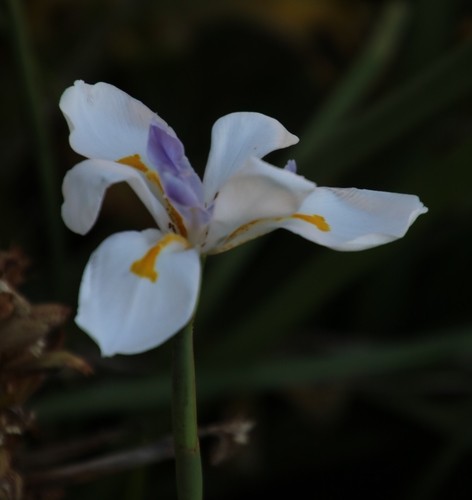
[0,248,91,500]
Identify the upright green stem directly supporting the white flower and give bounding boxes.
[172,319,202,500]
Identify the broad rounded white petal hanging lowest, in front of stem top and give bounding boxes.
[76,229,201,356]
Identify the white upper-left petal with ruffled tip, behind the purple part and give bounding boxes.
[59,80,170,160]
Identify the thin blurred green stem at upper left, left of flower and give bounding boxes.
[7,0,64,293]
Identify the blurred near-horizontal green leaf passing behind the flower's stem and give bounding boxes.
[35,328,472,424]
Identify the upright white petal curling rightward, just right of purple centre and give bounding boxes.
[203,112,298,203]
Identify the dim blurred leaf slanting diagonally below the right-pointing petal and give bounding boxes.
[207,249,388,363]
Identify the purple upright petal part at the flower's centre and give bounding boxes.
[147,120,212,229]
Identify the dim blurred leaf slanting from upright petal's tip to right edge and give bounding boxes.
[295,41,472,183]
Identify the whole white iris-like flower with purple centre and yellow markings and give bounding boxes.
[60,81,427,356]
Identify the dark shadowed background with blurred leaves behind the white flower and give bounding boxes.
[0,0,472,500]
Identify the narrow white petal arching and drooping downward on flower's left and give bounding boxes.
[62,160,169,234]
